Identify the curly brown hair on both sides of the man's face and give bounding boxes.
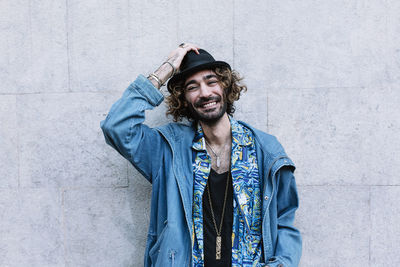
[166,67,247,121]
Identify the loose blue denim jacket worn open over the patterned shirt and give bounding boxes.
[101,75,302,267]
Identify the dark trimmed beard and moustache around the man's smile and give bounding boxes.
[188,96,228,124]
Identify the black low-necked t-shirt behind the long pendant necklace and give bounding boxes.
[203,169,233,267]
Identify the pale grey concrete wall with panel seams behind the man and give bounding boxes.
[0,0,400,267]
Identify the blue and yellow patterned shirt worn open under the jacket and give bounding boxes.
[192,118,262,267]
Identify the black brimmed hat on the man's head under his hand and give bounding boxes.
[167,49,231,92]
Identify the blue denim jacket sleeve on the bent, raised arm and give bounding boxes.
[100,75,165,182]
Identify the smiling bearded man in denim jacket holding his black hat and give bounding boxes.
[101,43,301,267]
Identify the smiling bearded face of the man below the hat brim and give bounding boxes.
[184,70,227,123]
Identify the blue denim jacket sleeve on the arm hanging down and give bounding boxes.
[267,166,302,267]
